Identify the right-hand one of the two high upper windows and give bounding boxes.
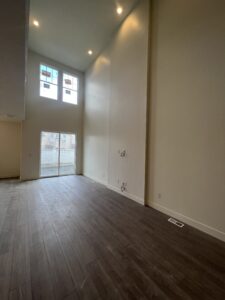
[63,73,78,104]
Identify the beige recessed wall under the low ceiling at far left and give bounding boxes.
[0,122,21,178]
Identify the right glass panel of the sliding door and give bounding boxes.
[59,133,76,175]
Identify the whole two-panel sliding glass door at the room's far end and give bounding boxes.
[40,132,76,177]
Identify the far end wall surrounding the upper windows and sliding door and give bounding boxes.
[21,51,83,180]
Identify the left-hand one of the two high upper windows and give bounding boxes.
[40,64,58,100]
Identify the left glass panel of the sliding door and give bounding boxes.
[40,132,59,177]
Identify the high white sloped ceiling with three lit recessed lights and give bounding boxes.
[29,0,138,71]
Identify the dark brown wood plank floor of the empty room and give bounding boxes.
[0,176,225,300]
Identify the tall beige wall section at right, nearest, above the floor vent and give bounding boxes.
[148,0,225,240]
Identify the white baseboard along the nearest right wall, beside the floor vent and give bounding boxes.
[149,202,225,242]
